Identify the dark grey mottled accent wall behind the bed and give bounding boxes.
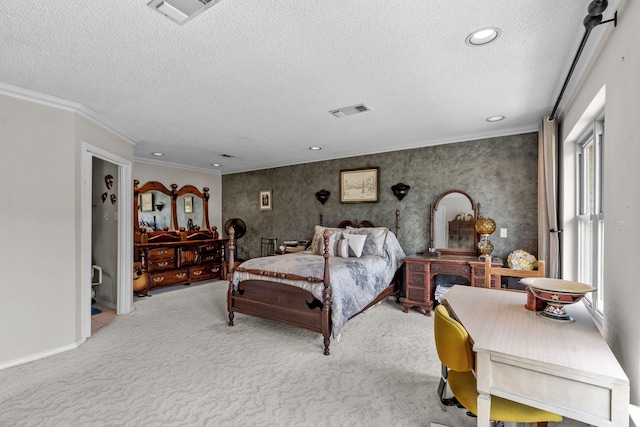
[221,133,538,259]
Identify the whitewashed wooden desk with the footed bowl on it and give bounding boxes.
[444,286,629,427]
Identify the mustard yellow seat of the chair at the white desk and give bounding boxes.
[448,370,562,423]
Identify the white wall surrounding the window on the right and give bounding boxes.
[559,0,640,405]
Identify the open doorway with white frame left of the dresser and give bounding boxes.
[79,143,133,341]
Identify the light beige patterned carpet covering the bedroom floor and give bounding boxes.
[0,282,583,427]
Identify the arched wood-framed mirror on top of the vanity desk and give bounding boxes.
[429,190,480,255]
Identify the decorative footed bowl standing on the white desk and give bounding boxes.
[520,277,596,322]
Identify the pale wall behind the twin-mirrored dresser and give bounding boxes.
[133,160,225,238]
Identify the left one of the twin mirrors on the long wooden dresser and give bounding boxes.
[133,181,174,231]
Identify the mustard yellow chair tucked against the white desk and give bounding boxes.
[434,305,562,427]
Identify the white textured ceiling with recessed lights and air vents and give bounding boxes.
[0,0,614,174]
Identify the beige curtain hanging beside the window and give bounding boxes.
[538,117,560,278]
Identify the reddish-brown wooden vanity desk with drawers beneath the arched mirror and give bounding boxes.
[403,255,502,316]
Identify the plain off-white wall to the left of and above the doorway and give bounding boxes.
[0,94,133,367]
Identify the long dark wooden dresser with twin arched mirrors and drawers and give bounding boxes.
[133,180,227,295]
